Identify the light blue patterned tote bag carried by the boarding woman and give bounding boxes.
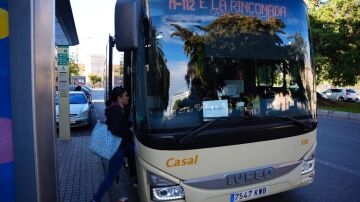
[89,122,122,160]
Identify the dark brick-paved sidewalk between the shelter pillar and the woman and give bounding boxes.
[57,136,109,202]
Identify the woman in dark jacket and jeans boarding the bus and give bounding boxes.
[92,87,135,202]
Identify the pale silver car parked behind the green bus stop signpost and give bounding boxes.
[55,91,91,127]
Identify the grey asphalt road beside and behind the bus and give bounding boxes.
[72,91,360,202]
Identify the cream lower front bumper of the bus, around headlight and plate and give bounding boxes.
[137,146,315,202]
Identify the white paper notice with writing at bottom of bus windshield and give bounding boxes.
[202,100,229,118]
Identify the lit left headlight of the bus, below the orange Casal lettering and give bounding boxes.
[148,173,185,201]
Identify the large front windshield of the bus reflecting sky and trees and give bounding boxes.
[137,0,316,131]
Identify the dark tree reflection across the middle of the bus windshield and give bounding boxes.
[171,14,311,111]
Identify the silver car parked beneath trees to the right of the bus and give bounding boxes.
[324,88,359,102]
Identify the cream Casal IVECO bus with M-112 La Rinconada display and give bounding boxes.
[115,0,317,202]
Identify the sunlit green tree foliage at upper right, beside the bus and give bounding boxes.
[310,0,360,86]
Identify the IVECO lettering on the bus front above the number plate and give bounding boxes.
[227,168,274,185]
